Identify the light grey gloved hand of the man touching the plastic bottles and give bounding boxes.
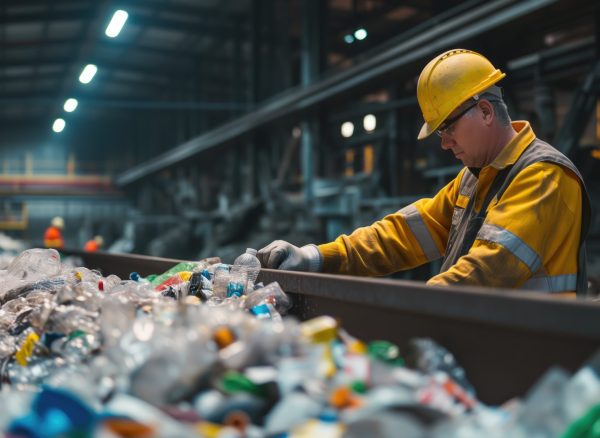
[256,240,321,272]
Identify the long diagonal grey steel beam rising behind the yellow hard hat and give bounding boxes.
[117,0,557,186]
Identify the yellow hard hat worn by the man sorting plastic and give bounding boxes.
[417,49,506,140]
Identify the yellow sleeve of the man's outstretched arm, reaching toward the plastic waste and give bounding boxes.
[319,169,465,276]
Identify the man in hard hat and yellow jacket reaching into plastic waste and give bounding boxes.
[258,49,590,295]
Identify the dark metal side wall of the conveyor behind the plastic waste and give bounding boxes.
[65,253,600,404]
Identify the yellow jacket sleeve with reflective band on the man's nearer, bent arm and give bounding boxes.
[428,162,582,292]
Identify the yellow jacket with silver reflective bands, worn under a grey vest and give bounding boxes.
[318,121,583,293]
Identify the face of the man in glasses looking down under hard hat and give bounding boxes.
[438,100,489,167]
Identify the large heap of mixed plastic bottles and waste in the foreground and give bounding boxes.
[0,249,600,438]
